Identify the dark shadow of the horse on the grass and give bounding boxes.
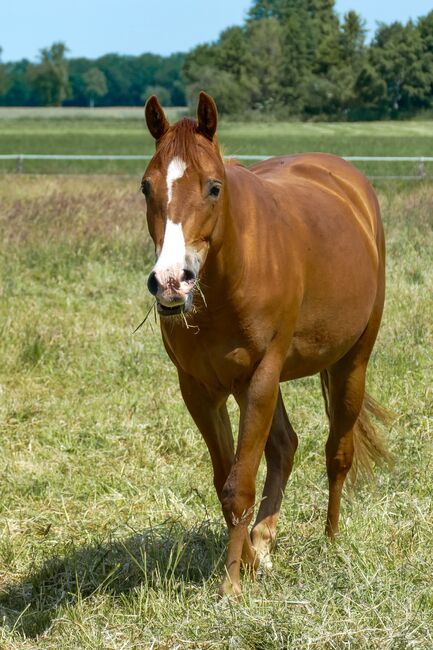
[0,520,225,638]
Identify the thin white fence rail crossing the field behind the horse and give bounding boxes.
[0,153,433,180]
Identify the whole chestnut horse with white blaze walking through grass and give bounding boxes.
[142,92,387,595]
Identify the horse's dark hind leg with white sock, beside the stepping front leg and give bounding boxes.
[252,390,298,569]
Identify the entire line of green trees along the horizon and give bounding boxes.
[0,0,433,119]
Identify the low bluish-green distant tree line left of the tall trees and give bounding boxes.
[0,43,186,106]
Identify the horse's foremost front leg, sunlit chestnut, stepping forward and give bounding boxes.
[220,355,280,596]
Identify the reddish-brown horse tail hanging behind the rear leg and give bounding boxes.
[320,372,395,483]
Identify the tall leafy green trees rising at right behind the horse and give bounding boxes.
[184,0,433,119]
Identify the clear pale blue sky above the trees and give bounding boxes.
[0,0,433,61]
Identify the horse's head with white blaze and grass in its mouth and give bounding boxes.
[141,92,225,316]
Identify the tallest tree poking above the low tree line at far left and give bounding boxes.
[29,42,70,106]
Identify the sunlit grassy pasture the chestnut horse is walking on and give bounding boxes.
[0,173,433,650]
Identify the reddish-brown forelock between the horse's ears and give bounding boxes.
[153,117,219,169]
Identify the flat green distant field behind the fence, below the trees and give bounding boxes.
[0,108,433,176]
